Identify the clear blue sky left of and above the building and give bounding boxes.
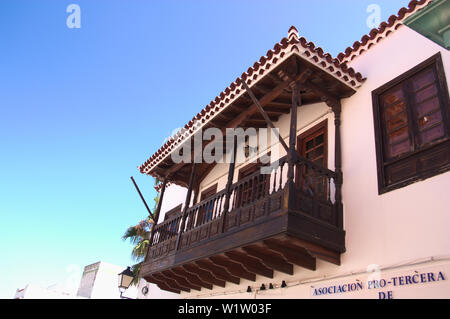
[0,0,409,298]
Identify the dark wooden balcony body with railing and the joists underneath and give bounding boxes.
[140,157,345,293]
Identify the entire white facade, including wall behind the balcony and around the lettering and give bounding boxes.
[145,11,450,299]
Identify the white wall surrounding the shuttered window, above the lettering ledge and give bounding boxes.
[342,26,450,268]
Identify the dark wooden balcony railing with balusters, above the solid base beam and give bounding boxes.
[148,157,342,268]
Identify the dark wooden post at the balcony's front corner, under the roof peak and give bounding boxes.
[287,82,301,208]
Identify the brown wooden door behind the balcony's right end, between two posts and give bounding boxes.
[296,120,328,199]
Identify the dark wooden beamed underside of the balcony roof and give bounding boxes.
[147,52,356,187]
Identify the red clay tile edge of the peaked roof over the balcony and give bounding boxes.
[139,26,365,176]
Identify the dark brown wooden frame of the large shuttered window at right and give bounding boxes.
[372,52,450,195]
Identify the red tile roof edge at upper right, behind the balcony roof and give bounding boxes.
[338,0,433,63]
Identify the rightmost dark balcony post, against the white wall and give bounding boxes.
[332,100,344,229]
